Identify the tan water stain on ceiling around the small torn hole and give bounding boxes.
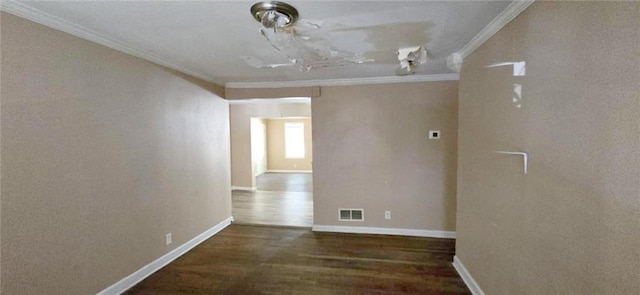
[334,21,435,64]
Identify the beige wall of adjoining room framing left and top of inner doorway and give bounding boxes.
[229,103,311,188]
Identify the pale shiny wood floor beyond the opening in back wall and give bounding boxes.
[231,173,313,227]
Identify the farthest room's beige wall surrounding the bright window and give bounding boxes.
[267,118,313,171]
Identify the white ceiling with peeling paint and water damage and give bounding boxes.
[8,1,509,84]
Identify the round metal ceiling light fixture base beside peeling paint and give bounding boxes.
[251,1,298,28]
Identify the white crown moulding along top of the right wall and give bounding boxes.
[458,0,534,59]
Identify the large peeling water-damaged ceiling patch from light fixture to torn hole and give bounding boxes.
[241,20,435,72]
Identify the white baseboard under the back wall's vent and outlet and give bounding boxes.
[311,225,456,239]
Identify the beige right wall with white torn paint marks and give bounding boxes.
[456,2,640,294]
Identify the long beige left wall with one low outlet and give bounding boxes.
[1,13,231,294]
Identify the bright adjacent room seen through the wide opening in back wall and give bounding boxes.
[230,98,313,228]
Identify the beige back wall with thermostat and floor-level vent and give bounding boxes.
[312,81,458,231]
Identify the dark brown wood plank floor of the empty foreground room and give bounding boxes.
[125,224,470,295]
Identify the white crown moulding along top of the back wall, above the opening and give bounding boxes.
[225,74,460,88]
